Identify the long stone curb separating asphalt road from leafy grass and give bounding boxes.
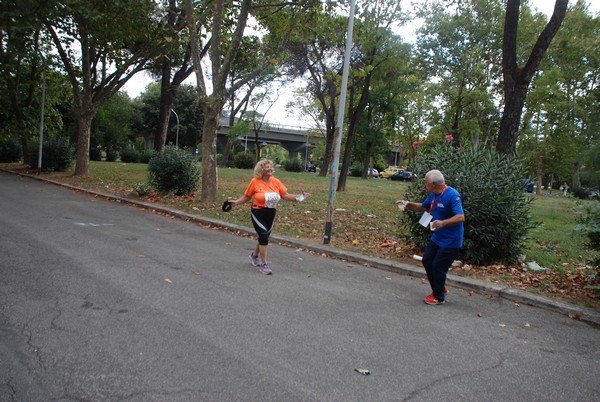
[0,168,600,328]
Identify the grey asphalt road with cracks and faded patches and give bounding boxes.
[0,173,600,401]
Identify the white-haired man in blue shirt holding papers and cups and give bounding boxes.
[396,170,465,305]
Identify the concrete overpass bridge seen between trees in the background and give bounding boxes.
[217,116,323,164]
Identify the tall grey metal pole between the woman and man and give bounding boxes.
[323,0,356,244]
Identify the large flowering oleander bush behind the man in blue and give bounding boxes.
[402,142,533,264]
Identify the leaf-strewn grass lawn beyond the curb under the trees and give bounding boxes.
[5,162,600,308]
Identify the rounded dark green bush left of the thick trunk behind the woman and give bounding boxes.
[148,145,200,195]
